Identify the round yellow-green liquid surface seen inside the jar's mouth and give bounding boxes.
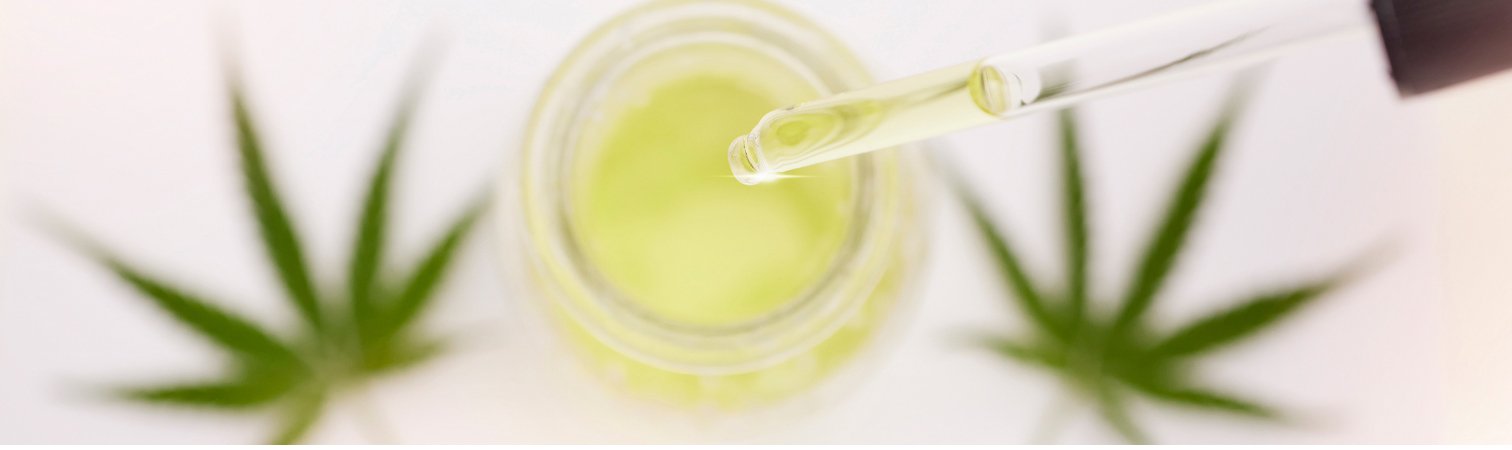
[570,44,854,326]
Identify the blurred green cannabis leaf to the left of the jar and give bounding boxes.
[63,67,482,442]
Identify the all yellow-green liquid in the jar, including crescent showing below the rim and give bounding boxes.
[558,42,903,409]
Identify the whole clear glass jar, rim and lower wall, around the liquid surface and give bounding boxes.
[508,0,921,409]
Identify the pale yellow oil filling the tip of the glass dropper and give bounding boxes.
[729,62,1037,184]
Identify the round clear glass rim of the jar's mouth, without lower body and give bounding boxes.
[522,0,900,374]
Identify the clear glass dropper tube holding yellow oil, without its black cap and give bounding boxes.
[729,0,1373,184]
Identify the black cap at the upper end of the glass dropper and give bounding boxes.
[1371,0,1512,95]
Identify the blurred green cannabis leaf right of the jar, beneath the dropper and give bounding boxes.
[956,97,1356,442]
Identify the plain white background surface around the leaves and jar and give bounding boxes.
[0,0,1512,442]
